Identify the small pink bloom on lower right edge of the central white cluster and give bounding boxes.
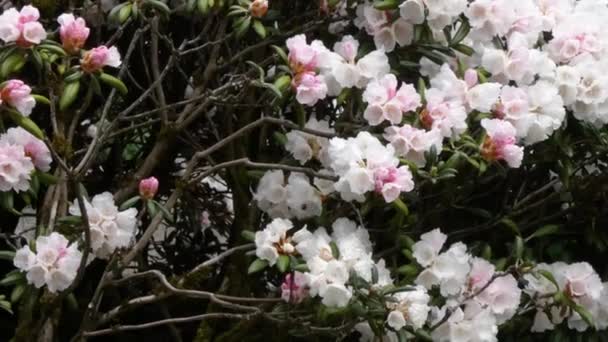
[374,166,414,203]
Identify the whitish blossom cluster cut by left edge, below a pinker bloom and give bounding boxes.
[0,142,34,191]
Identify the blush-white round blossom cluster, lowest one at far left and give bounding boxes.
[13,233,82,292]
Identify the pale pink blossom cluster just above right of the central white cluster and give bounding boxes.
[384,125,443,166]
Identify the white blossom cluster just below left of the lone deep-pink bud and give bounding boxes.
[69,192,137,259]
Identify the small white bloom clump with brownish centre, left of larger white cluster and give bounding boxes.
[255,218,295,266]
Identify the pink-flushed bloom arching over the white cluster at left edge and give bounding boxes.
[0,127,53,172]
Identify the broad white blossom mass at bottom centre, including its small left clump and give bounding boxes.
[255,218,392,307]
